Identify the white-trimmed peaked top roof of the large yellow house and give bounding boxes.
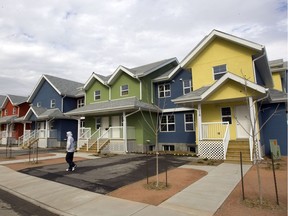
[180,29,273,88]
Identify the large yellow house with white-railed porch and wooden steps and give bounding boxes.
[173,30,273,160]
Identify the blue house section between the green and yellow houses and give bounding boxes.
[153,65,196,152]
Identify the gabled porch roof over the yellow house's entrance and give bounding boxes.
[172,72,267,105]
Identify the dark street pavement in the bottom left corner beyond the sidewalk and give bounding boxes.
[0,189,57,216]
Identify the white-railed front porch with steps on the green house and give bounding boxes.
[77,126,136,154]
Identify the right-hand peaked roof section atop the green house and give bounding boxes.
[108,58,178,84]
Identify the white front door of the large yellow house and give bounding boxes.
[235,105,251,139]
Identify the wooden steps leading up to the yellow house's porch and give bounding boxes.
[225,140,251,163]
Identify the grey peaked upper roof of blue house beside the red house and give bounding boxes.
[28,74,84,103]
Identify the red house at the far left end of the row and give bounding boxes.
[0,95,30,145]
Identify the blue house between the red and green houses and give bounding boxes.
[21,75,84,148]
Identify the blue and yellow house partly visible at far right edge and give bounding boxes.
[259,59,287,156]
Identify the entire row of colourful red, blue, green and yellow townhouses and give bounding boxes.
[0,30,287,160]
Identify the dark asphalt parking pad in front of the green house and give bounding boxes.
[21,154,191,194]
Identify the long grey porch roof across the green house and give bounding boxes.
[65,97,159,116]
